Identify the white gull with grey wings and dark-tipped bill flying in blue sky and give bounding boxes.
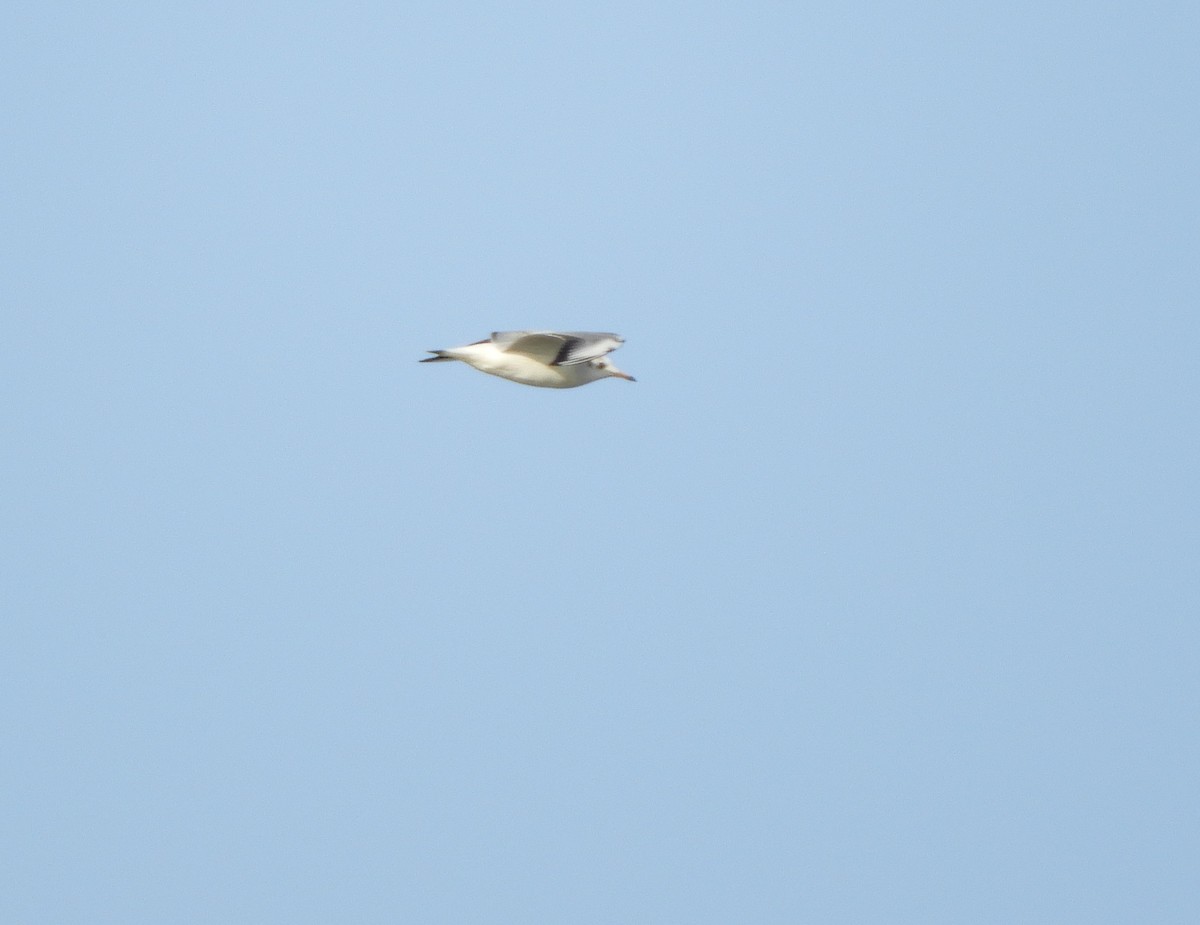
[421,331,636,389]
